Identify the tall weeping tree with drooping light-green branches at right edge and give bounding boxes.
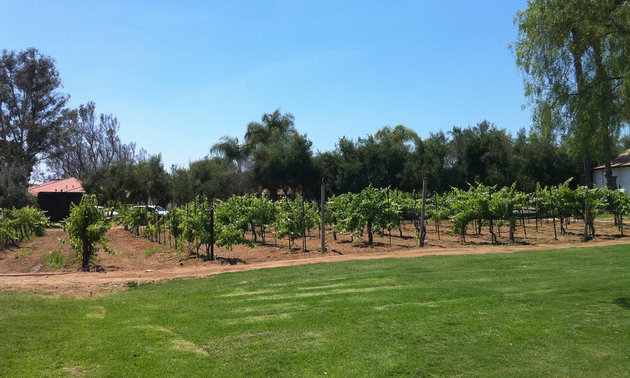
[512,0,630,186]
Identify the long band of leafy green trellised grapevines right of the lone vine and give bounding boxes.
[126,179,630,255]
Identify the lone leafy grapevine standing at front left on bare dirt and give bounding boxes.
[63,195,114,269]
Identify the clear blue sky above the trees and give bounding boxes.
[0,0,531,168]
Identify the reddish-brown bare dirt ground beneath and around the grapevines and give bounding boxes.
[0,219,630,297]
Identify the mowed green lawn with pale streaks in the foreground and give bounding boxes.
[0,246,630,377]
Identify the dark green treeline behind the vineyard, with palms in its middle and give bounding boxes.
[81,110,626,206]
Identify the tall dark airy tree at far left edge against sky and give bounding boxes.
[0,48,69,198]
